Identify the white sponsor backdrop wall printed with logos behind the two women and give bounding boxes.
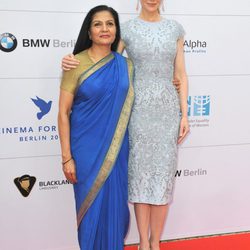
[0,0,250,250]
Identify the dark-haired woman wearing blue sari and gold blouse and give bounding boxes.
[58,5,134,250]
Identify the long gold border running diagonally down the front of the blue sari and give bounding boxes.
[77,61,134,227]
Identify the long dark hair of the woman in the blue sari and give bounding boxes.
[73,5,121,55]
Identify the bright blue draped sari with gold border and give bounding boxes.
[61,51,134,250]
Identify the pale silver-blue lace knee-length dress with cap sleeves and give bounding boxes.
[121,17,184,205]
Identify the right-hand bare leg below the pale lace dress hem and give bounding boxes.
[150,205,168,250]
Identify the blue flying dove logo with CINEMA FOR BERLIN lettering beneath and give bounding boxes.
[0,96,59,143]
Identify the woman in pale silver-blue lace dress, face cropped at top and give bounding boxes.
[62,0,189,250]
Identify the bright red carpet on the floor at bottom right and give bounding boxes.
[125,232,250,250]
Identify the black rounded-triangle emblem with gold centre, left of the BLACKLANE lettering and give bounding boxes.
[14,174,36,197]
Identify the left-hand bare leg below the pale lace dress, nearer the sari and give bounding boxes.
[134,203,151,250]
